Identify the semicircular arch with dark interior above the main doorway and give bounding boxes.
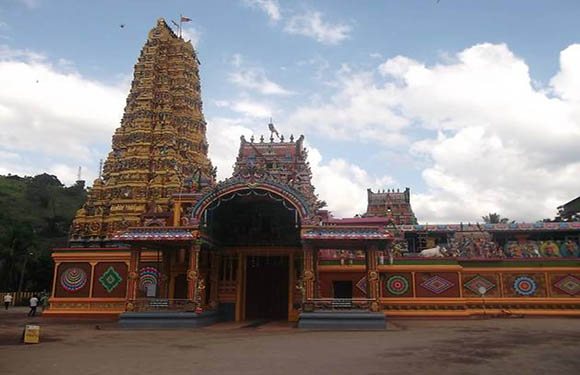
[200,188,302,246]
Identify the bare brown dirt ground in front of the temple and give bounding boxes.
[0,308,580,375]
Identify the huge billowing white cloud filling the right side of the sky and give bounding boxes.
[288,44,580,223]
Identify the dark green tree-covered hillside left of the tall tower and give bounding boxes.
[0,174,86,291]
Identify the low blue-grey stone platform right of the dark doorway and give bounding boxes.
[298,311,387,331]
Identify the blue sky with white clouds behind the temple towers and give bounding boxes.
[0,0,580,223]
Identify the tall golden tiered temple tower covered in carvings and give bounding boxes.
[70,19,215,246]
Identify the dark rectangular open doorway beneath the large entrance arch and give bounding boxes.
[246,256,289,320]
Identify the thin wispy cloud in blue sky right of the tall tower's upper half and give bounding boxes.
[228,54,293,95]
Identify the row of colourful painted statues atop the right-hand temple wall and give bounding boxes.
[319,237,580,264]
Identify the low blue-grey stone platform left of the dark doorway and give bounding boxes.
[119,311,223,329]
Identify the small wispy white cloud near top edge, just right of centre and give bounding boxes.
[284,11,352,44]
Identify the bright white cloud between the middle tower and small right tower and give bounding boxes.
[308,147,394,217]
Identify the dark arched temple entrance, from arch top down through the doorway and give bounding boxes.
[201,188,301,320]
